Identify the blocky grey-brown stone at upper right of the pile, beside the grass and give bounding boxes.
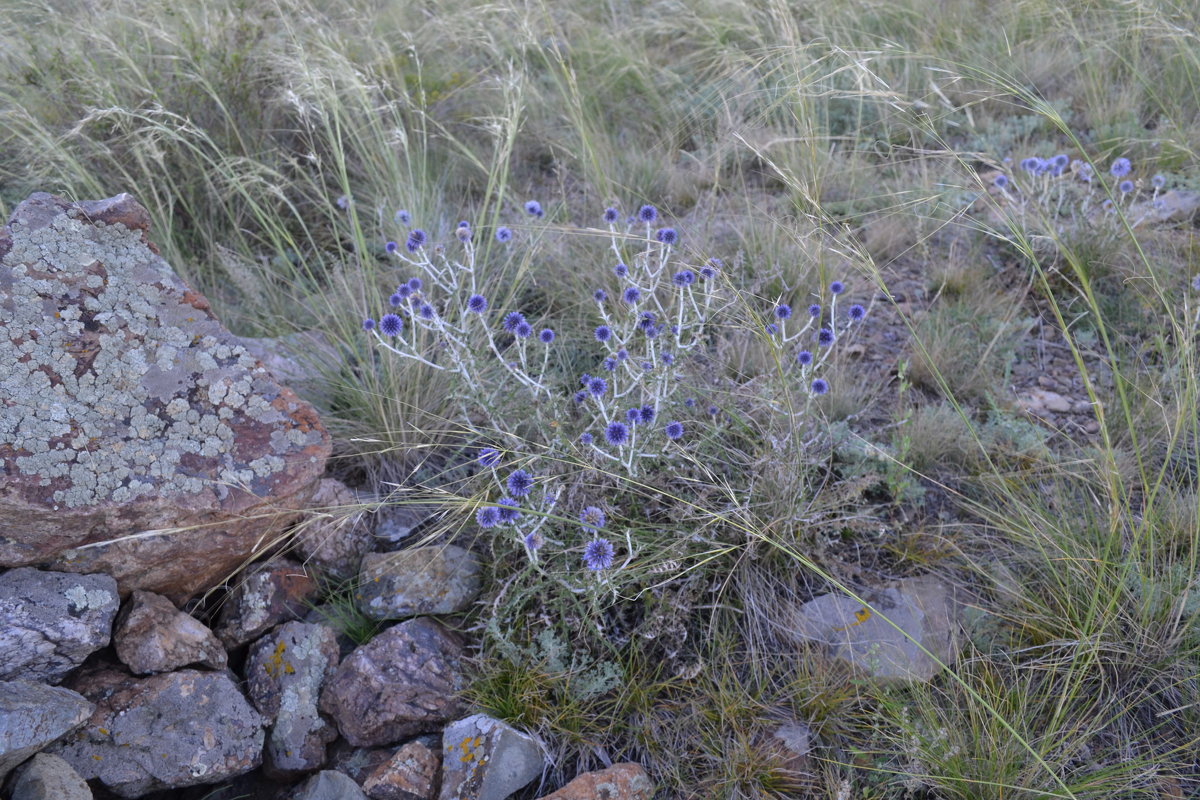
[354,545,479,619]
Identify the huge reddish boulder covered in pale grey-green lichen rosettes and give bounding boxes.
[0,192,330,602]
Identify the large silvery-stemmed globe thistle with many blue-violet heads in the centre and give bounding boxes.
[362,200,866,593]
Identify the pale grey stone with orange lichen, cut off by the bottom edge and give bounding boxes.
[439,714,544,800]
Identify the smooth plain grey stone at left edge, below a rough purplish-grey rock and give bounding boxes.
[0,680,92,781]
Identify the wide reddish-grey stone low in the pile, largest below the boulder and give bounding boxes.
[50,669,263,798]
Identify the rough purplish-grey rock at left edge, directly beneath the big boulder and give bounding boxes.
[0,567,120,684]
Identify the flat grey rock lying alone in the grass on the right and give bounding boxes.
[791,576,958,681]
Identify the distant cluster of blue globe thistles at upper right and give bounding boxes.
[991,154,1166,230]
